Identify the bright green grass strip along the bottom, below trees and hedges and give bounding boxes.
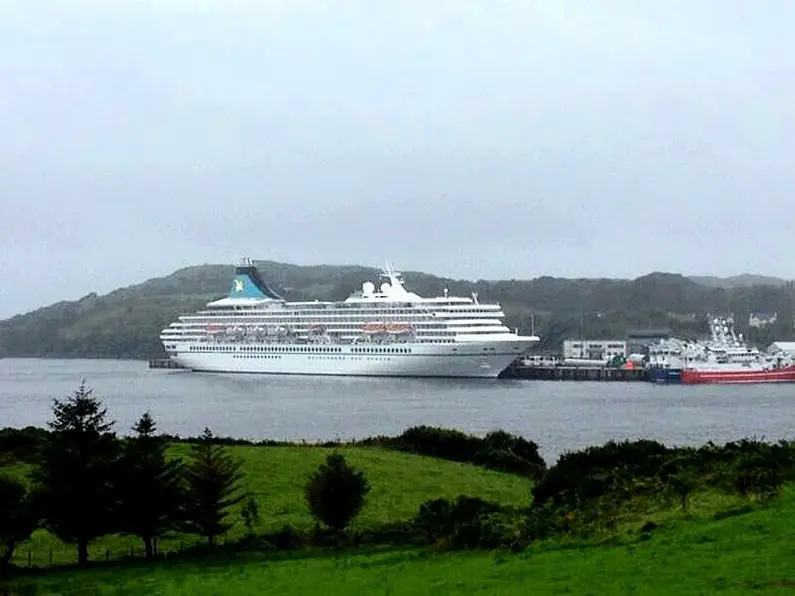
[9,486,795,596]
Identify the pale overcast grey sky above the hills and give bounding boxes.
[0,0,795,318]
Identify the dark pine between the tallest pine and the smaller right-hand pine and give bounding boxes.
[117,412,183,559]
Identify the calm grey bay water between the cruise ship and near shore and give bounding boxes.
[0,359,795,460]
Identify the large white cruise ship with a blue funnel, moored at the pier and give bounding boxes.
[160,259,539,378]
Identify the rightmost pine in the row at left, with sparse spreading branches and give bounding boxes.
[185,428,246,546]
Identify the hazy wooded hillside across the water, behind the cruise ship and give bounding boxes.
[0,261,795,358]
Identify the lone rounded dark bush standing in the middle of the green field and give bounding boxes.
[306,454,370,531]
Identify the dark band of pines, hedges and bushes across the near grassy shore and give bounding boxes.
[0,385,795,565]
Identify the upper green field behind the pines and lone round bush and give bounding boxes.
[4,444,530,567]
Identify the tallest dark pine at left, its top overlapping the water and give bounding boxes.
[33,381,119,565]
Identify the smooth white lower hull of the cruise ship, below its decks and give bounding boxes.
[172,341,528,378]
